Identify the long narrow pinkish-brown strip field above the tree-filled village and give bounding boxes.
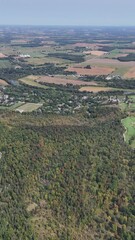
[36,76,97,86]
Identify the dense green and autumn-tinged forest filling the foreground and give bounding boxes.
[0,107,135,240]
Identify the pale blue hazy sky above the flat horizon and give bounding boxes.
[0,0,135,26]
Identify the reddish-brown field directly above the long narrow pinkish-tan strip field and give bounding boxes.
[66,66,115,76]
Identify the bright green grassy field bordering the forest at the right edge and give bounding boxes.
[122,117,135,148]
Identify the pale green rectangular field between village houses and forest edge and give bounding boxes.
[15,103,43,113]
